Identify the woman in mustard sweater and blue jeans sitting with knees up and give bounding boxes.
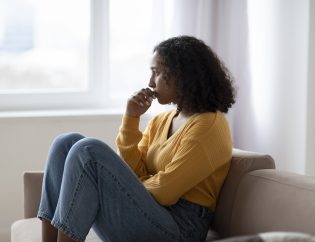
[38,36,235,242]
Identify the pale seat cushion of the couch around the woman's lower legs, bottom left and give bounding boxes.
[11,218,101,242]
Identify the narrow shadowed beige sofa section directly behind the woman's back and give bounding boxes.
[213,149,275,236]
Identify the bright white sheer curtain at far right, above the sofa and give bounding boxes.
[248,0,315,174]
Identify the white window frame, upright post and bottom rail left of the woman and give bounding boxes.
[0,0,115,111]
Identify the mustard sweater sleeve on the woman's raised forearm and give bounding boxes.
[116,116,150,177]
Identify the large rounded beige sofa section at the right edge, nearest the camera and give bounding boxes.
[228,170,315,236]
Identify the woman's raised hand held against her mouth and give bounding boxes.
[126,88,155,118]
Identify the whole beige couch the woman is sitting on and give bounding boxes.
[11,149,315,242]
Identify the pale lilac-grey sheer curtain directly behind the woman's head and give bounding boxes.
[168,0,257,148]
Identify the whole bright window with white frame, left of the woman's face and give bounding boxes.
[0,0,174,110]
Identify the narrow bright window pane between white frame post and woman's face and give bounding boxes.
[109,0,153,99]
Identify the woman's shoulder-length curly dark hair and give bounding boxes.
[154,36,235,113]
